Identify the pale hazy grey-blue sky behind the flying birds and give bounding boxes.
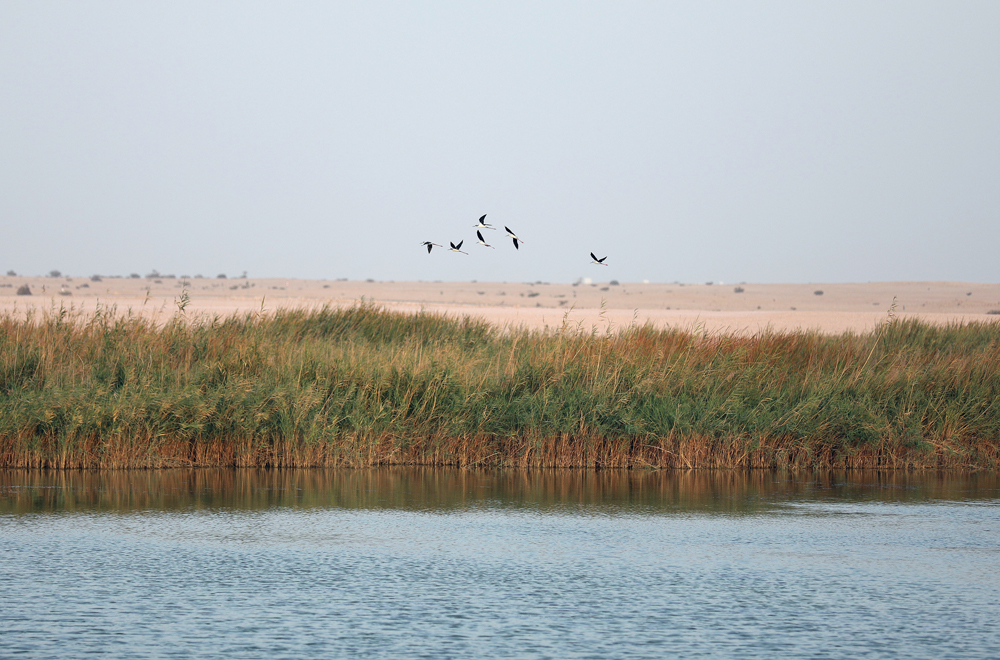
[0,0,1000,283]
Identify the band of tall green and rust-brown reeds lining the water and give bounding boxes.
[0,304,1000,469]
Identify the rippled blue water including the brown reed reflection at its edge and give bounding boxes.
[0,469,1000,658]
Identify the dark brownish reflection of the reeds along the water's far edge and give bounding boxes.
[0,468,1000,513]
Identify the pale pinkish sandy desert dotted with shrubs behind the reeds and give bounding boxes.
[0,276,1000,333]
